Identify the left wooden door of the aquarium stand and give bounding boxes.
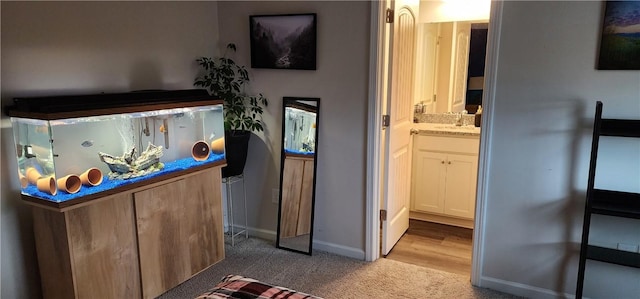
[66,193,141,298]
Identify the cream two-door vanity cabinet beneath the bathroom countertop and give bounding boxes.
[411,135,479,227]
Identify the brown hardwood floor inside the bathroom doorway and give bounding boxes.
[386,219,473,276]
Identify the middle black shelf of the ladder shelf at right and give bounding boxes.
[591,189,640,219]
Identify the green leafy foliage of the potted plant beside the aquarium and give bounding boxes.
[194,43,268,132]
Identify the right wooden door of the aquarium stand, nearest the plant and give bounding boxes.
[134,167,224,298]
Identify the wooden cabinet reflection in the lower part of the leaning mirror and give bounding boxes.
[280,156,314,238]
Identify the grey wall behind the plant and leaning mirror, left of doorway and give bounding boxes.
[218,1,370,258]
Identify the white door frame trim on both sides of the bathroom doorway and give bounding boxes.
[365,1,501,285]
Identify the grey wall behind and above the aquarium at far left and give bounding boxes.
[0,1,218,298]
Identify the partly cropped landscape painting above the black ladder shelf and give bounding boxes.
[598,1,640,70]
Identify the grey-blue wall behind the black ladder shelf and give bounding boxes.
[481,1,640,298]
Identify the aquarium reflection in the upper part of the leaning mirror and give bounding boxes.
[283,103,316,155]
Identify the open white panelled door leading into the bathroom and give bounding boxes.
[382,0,416,255]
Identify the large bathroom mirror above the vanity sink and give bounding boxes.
[414,20,489,114]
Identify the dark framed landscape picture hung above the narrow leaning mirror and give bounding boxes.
[249,13,317,70]
